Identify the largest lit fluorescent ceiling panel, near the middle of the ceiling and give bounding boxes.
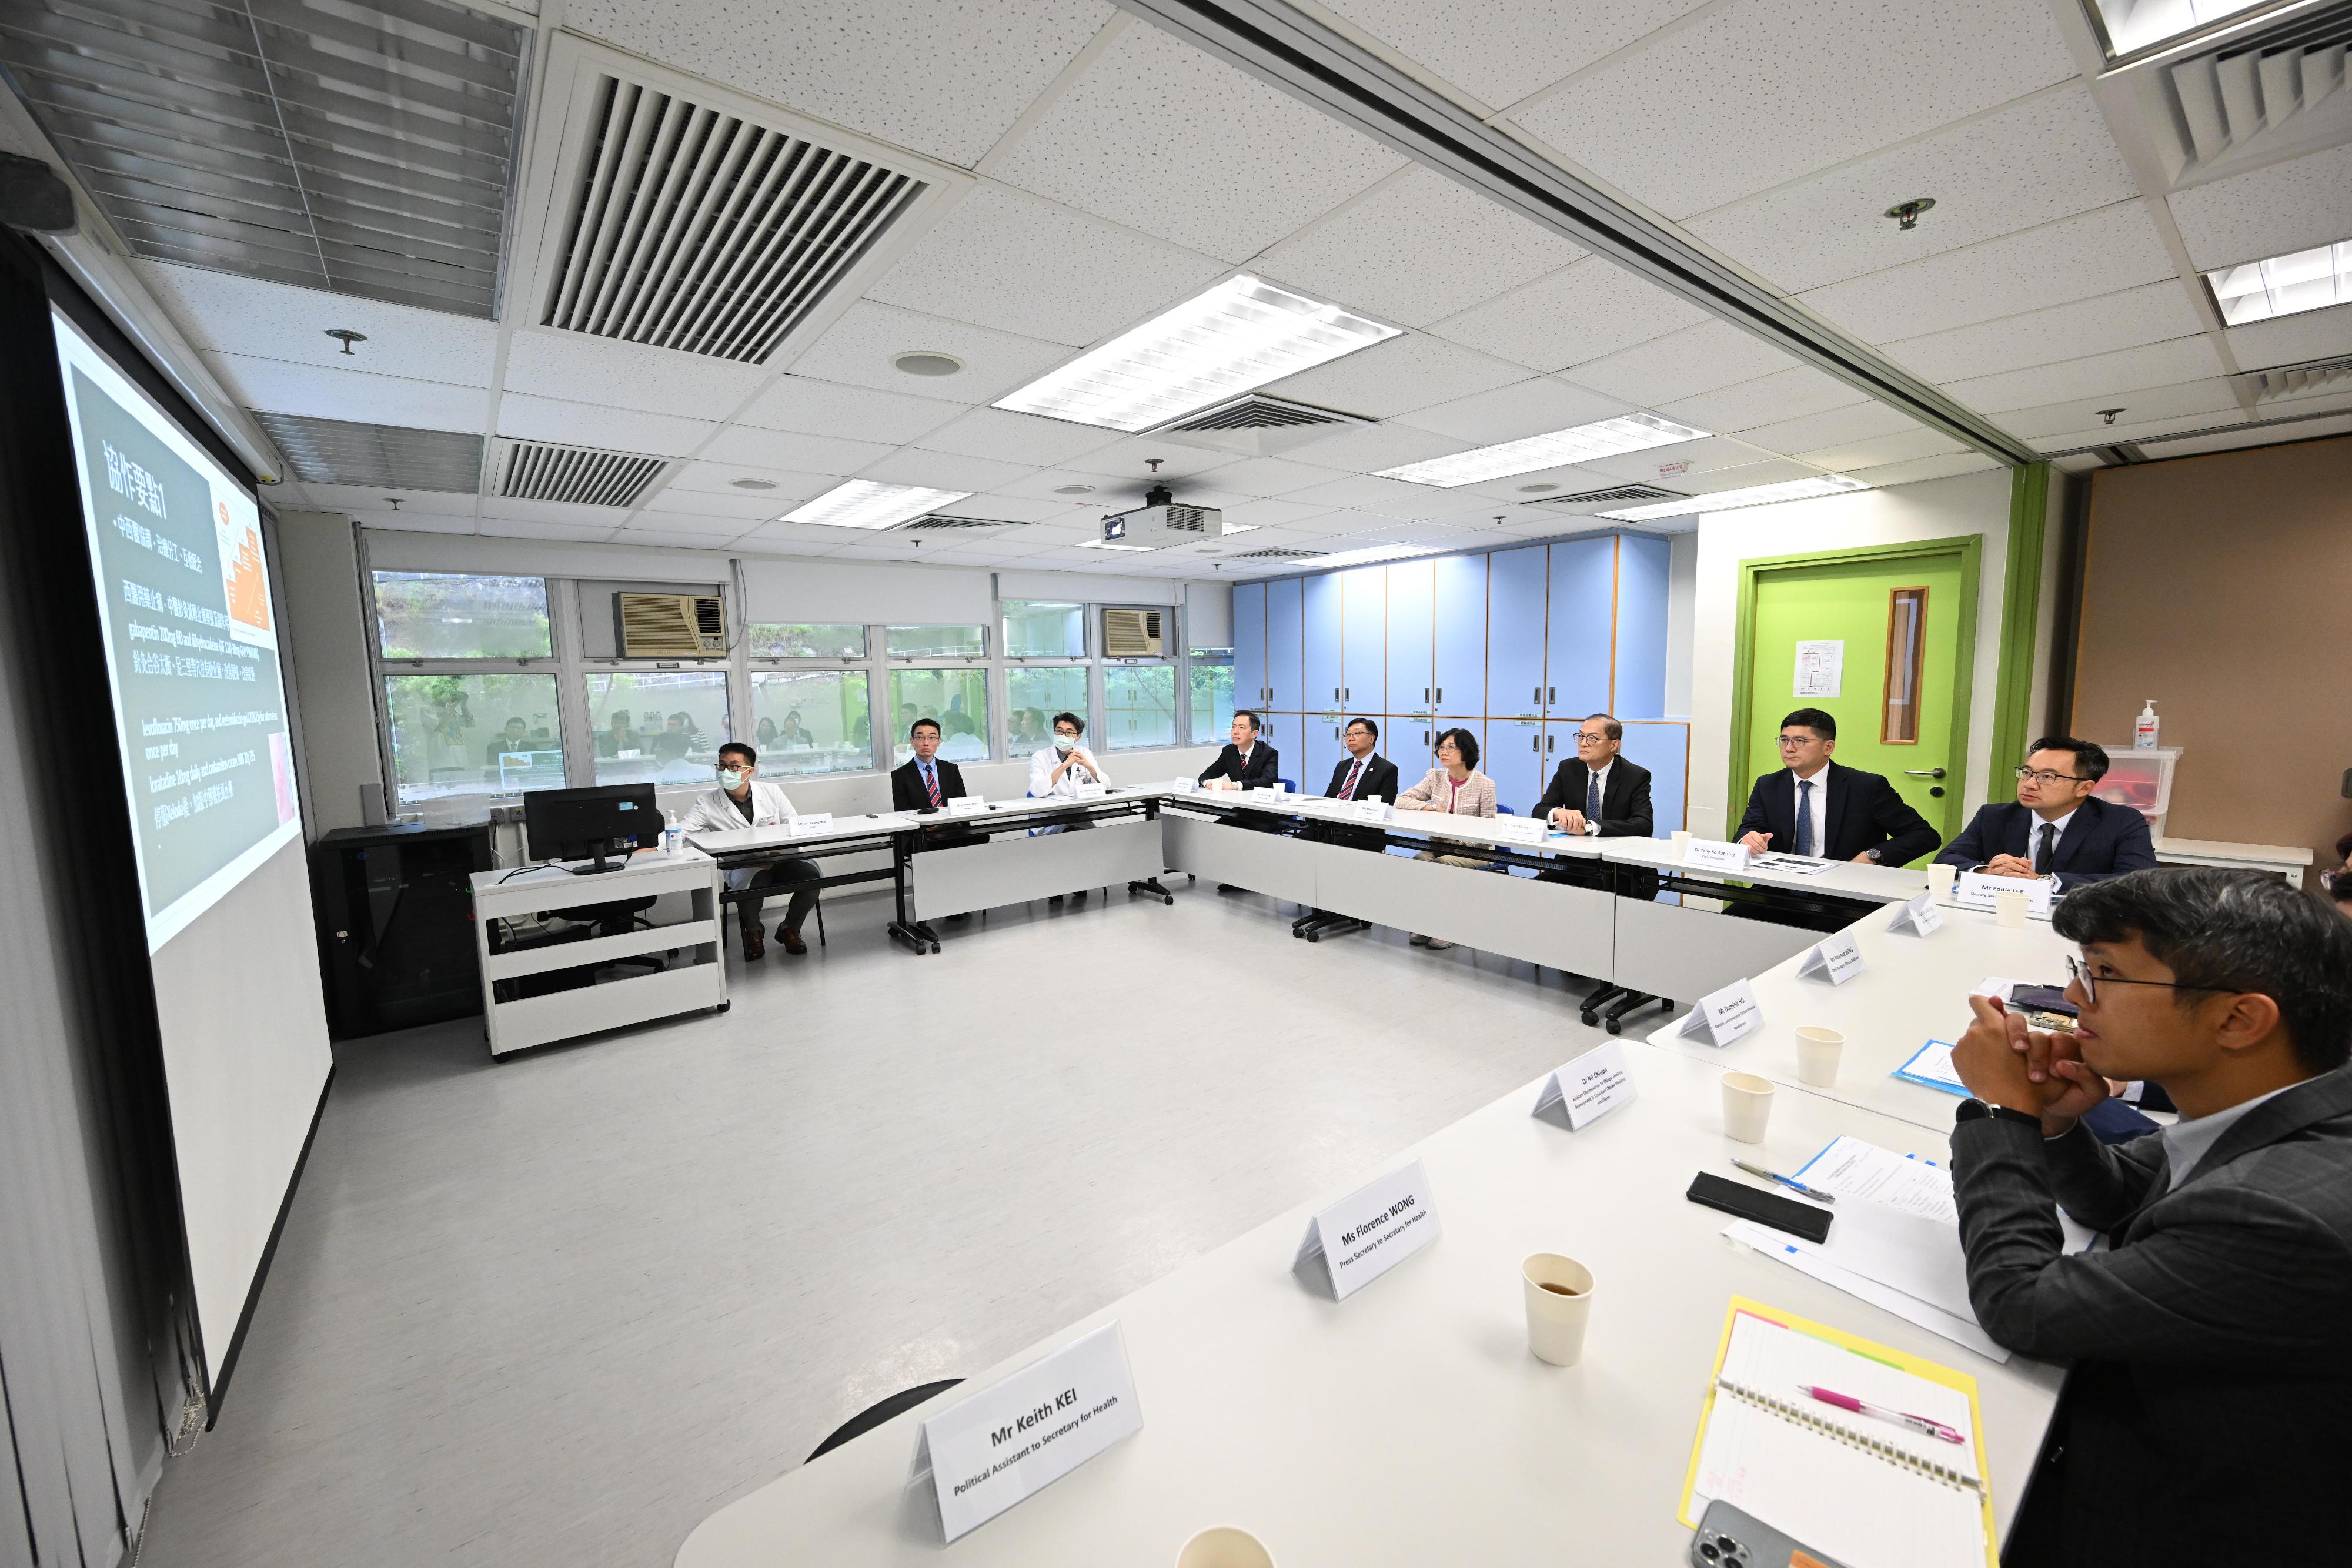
[995,275,1397,430]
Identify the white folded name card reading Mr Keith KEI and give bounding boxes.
[910,1323,1143,1540]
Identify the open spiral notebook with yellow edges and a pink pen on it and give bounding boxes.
[1682,1298,1999,1568]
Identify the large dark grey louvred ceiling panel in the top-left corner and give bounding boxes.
[0,0,527,317]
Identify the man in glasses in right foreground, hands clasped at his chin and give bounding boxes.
[1952,867,2352,1568]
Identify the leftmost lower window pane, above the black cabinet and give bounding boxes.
[383,675,564,806]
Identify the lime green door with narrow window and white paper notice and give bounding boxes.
[1733,548,1976,841]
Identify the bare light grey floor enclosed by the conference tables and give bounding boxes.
[141,879,1628,1568]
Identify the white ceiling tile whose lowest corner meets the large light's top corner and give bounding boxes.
[988,21,1404,263]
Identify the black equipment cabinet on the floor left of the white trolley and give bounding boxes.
[310,823,492,1039]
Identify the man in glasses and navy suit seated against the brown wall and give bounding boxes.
[1936,736,2157,893]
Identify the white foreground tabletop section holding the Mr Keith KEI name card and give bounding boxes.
[677,1044,2060,1568]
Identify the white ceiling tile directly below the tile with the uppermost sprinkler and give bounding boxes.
[1799,200,2178,343]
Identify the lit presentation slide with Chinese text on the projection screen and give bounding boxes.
[52,315,301,952]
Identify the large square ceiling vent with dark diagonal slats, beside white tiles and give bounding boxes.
[541,78,924,362]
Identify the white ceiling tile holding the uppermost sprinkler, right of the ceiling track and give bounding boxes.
[1686,82,2138,292]
